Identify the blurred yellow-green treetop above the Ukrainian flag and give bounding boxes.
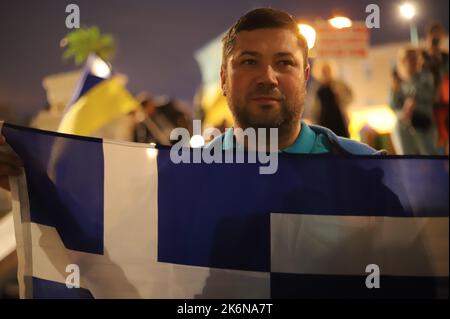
[61,26,116,65]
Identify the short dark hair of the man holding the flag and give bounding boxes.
[222,8,308,68]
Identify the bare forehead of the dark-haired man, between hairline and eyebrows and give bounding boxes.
[233,28,301,55]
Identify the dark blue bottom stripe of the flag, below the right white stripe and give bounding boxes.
[270,273,449,299]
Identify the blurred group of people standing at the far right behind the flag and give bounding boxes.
[390,24,449,155]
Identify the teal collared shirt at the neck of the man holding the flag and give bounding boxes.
[223,121,330,154]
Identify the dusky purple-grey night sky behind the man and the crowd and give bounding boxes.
[0,0,449,123]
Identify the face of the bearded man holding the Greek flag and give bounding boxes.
[221,28,309,130]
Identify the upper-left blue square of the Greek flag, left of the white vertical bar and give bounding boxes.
[3,124,104,254]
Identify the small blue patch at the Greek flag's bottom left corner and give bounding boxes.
[33,277,94,299]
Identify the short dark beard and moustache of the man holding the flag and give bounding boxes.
[227,84,306,135]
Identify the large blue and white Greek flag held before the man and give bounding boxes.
[2,124,449,298]
